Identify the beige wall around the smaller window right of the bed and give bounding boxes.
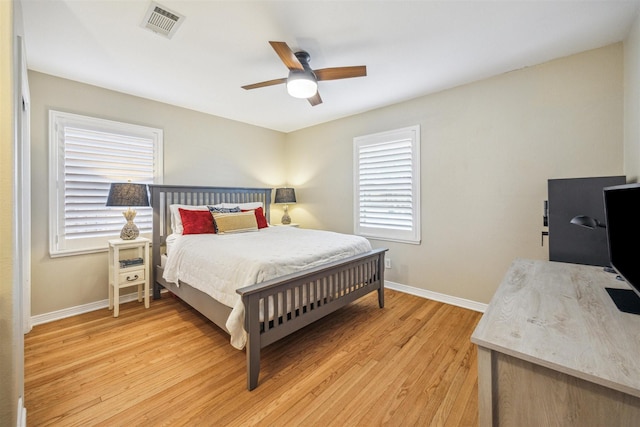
[287,43,623,303]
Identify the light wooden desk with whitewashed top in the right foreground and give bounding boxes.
[471,259,640,427]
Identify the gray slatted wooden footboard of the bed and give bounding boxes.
[236,249,387,390]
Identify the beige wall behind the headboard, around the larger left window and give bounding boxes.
[29,72,286,315]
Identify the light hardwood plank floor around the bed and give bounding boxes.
[25,290,481,426]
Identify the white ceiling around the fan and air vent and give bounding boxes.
[21,0,639,132]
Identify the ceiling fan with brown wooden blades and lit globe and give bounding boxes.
[242,42,367,106]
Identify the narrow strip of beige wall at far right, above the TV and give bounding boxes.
[624,12,640,182]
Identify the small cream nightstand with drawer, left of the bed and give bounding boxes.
[109,237,151,317]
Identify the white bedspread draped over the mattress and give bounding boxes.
[163,227,371,349]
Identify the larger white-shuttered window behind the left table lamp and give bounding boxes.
[49,110,163,257]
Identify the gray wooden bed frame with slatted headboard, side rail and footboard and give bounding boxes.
[150,185,386,390]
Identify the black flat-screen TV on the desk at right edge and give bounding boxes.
[603,184,640,314]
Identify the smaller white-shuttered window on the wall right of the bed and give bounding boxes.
[353,125,420,244]
